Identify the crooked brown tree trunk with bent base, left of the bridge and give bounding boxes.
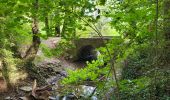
[24,0,41,60]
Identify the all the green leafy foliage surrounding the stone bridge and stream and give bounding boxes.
[0,0,169,100]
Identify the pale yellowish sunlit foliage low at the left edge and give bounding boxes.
[0,49,26,85]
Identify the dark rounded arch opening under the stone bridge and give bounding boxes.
[77,45,97,61]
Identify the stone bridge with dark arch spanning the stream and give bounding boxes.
[70,36,113,60]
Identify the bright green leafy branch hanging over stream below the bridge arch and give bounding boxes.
[62,56,108,85]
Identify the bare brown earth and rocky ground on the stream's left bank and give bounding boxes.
[0,38,86,100]
